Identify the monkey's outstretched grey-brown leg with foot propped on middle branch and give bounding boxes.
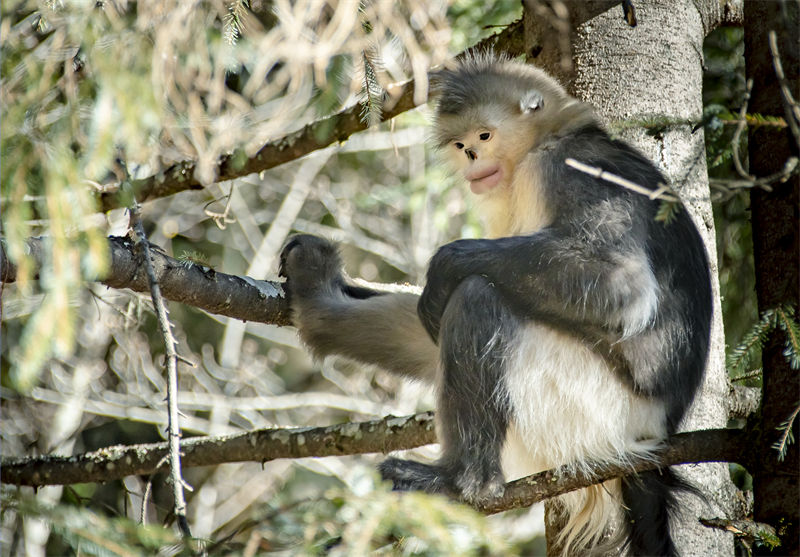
[281,235,438,381]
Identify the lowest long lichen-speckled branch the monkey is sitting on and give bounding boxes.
[0,420,747,514]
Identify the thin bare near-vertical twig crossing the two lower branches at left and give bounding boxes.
[131,205,192,538]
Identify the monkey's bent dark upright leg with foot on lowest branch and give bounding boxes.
[380,276,519,500]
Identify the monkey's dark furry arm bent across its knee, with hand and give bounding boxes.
[418,227,658,339]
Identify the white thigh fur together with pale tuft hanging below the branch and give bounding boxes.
[502,323,666,547]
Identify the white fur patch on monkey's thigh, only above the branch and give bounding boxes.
[504,323,666,479]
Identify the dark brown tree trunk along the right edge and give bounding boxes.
[745,1,800,555]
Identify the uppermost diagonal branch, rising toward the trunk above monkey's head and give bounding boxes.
[95,20,523,211]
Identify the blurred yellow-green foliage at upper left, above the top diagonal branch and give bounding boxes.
[0,0,454,390]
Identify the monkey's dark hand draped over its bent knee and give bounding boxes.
[417,240,480,343]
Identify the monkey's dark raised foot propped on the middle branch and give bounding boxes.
[279,234,343,304]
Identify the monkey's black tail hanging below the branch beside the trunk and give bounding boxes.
[622,468,702,557]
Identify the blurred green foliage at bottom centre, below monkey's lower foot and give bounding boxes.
[231,477,511,556]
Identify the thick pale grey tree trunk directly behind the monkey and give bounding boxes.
[525,0,735,556]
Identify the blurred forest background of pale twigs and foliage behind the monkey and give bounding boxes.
[0,0,758,556]
